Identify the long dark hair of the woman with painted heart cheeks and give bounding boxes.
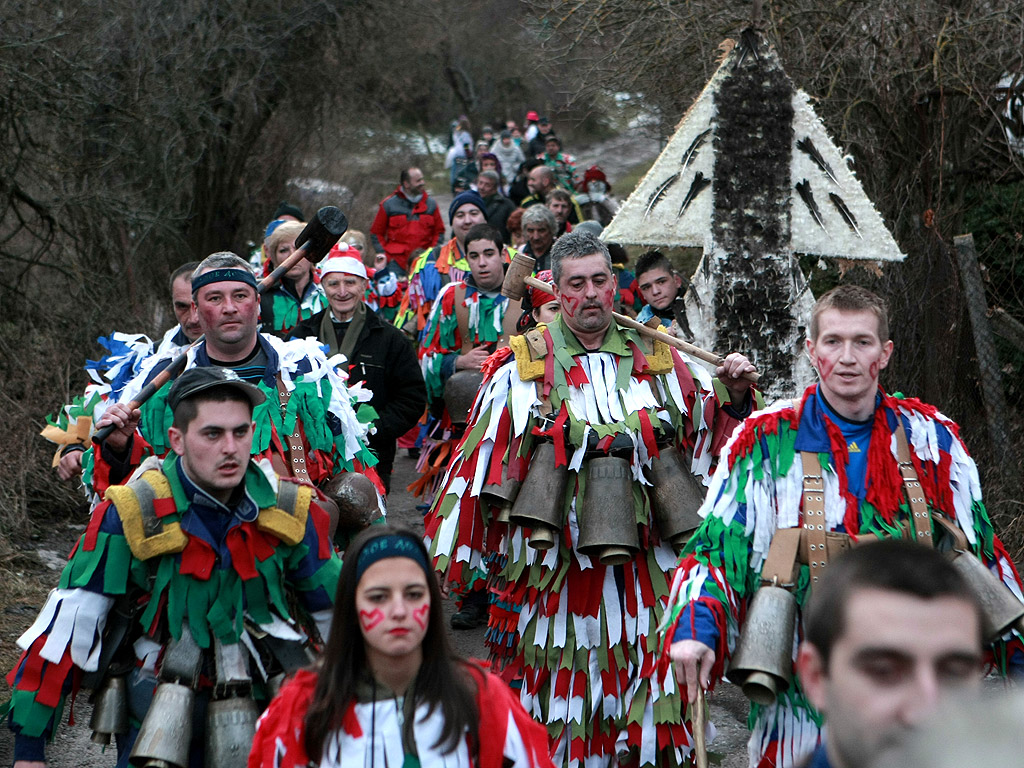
[305,524,479,764]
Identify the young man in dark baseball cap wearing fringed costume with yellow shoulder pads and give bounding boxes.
[8,367,341,768]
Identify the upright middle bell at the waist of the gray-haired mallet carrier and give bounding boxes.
[577,456,640,565]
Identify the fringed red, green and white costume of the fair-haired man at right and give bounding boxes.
[660,386,1024,768]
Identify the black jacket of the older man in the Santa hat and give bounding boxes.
[292,308,427,473]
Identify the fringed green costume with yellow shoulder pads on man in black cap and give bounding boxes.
[7,455,341,759]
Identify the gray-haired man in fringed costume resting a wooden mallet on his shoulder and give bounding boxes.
[426,231,754,768]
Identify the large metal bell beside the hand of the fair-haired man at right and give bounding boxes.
[726,586,797,706]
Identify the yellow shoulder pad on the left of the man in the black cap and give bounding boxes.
[103,470,188,560]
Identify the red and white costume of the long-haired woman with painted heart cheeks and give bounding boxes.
[249,664,551,768]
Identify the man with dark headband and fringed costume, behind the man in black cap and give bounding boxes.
[89,252,383,505]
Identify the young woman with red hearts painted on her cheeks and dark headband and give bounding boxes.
[249,525,551,768]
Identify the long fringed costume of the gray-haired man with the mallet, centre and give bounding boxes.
[426,319,749,768]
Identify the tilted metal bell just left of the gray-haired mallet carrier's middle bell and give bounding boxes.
[509,442,569,550]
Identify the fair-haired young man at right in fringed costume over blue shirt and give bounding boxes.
[663,286,1024,767]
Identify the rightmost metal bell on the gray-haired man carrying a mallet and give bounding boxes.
[647,445,707,552]
